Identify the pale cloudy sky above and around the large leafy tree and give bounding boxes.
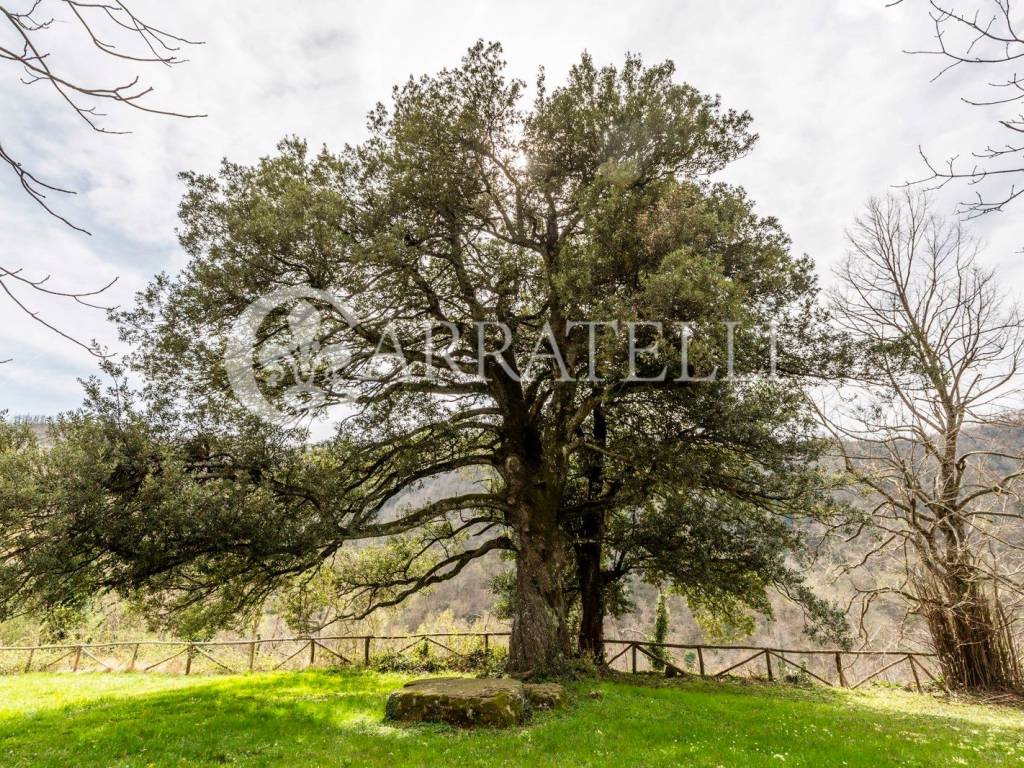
[0,0,1024,415]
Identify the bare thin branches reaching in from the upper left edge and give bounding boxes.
[0,0,202,354]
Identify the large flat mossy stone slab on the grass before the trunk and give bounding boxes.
[386,678,526,727]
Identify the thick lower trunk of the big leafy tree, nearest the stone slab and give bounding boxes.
[508,507,570,677]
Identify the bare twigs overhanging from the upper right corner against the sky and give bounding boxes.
[891,0,1024,218]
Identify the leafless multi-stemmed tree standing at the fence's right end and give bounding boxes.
[820,194,1024,688]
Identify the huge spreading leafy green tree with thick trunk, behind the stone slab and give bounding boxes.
[0,43,837,673]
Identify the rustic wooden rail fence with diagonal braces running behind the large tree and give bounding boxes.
[0,632,939,690]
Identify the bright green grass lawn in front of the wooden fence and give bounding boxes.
[0,672,1024,768]
